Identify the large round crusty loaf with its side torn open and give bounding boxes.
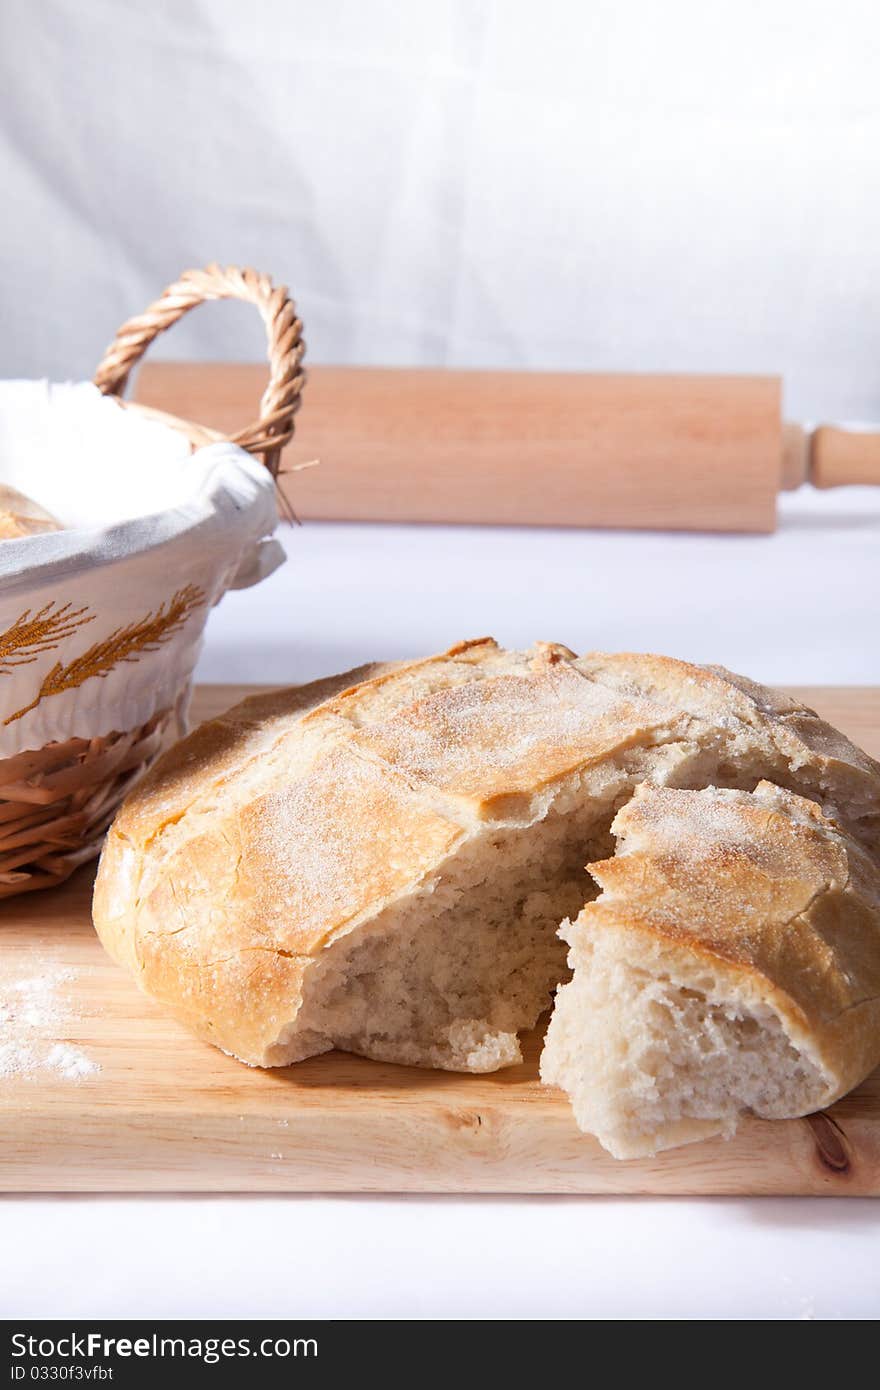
[95,638,880,1148]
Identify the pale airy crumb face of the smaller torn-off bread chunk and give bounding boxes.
[541,930,827,1158]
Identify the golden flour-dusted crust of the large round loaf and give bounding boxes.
[93,638,880,1063]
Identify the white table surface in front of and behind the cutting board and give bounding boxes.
[0,488,880,1319]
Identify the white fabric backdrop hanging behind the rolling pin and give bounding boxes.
[0,0,880,418]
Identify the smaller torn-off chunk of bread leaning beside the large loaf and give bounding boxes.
[541,781,880,1158]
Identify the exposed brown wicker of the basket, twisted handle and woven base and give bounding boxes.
[0,265,304,897]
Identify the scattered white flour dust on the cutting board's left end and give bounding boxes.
[0,969,100,1081]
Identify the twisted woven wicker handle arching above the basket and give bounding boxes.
[95,265,306,478]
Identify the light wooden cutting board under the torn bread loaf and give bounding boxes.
[0,687,880,1195]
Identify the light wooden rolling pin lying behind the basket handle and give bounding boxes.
[136,363,880,531]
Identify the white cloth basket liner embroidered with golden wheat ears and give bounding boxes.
[0,381,284,758]
